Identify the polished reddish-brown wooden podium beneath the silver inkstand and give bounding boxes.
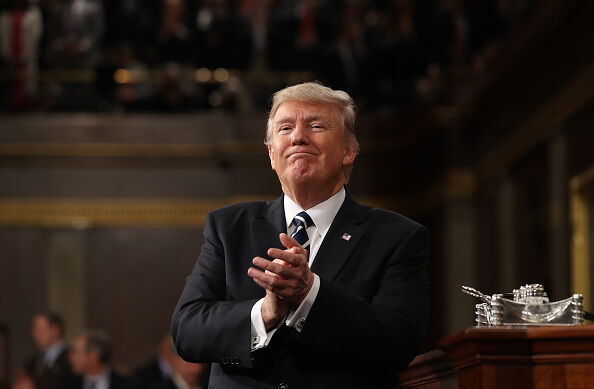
[399,325,594,389]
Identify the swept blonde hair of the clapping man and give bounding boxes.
[264,81,359,182]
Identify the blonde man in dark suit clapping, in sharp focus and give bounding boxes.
[171,83,429,389]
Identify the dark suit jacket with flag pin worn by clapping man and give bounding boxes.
[171,191,429,389]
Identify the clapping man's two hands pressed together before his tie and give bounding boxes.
[248,234,314,306]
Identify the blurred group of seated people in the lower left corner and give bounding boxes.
[8,311,208,389]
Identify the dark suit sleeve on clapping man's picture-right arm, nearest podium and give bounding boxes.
[298,224,429,367]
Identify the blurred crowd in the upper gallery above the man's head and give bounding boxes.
[0,0,541,112]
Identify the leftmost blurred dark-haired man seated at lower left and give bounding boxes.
[15,312,72,389]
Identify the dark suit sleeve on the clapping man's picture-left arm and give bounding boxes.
[171,214,256,367]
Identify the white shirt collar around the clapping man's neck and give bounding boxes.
[283,187,346,238]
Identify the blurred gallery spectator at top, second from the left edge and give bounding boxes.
[48,0,103,68]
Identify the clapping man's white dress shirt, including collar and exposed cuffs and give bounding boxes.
[251,188,346,351]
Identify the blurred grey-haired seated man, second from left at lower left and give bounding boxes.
[67,330,131,389]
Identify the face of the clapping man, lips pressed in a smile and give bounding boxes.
[268,101,356,188]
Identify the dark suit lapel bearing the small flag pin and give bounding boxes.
[311,191,369,281]
